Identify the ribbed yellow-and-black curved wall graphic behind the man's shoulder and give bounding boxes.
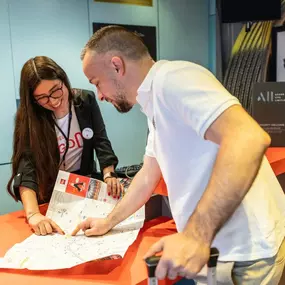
[223,21,272,113]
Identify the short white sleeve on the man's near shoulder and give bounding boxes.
[159,64,240,138]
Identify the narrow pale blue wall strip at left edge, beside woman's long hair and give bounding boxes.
[0,0,21,214]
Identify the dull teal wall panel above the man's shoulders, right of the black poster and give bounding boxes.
[158,0,209,67]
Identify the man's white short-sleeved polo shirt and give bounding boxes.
[137,61,285,261]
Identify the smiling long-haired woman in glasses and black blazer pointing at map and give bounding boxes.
[7,56,121,235]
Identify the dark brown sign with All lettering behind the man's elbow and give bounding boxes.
[252,82,285,147]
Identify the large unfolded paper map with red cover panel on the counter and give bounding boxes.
[0,171,145,270]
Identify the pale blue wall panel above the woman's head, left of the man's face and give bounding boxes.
[9,0,90,96]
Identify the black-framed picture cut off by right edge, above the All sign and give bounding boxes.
[270,26,285,82]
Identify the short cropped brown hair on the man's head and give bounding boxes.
[81,25,150,60]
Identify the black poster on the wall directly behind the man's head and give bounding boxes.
[93,23,157,61]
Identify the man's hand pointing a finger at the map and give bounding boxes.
[71,218,112,236]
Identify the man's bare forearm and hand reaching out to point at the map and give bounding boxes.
[72,156,161,236]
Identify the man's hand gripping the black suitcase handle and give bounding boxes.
[144,233,207,280]
